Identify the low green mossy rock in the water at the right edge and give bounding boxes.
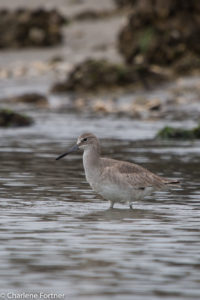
[156,125,200,140]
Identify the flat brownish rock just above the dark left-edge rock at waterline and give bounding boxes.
[7,93,48,107]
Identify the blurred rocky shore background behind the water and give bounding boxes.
[0,0,200,127]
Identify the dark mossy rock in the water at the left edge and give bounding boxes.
[0,109,33,127]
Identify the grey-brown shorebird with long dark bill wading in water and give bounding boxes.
[56,133,179,208]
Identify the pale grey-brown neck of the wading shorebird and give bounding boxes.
[83,145,100,180]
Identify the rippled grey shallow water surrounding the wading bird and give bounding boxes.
[0,118,200,299]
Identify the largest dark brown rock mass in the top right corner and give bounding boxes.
[118,0,200,71]
